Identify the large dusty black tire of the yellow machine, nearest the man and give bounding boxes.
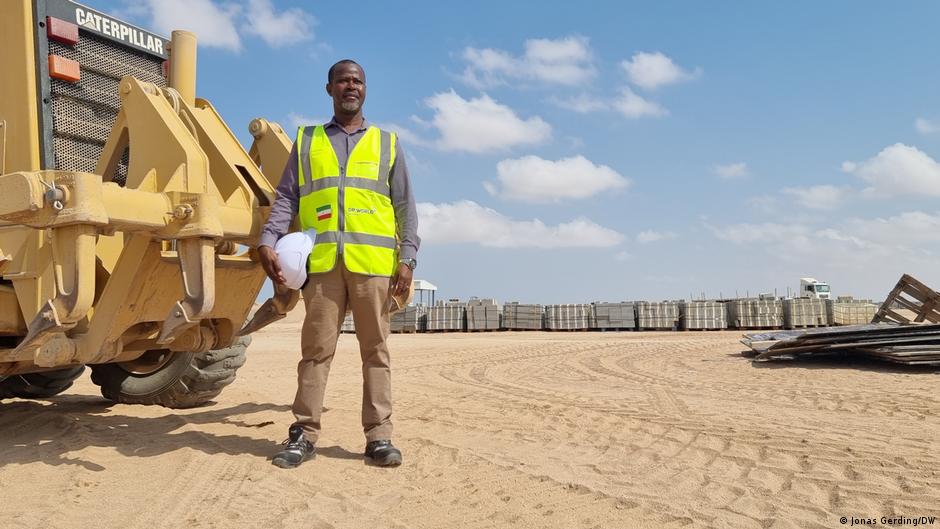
[91,336,251,408]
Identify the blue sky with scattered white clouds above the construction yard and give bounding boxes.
[90,0,940,303]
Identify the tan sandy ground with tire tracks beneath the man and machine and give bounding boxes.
[0,308,940,529]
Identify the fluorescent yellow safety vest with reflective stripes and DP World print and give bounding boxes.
[297,125,398,276]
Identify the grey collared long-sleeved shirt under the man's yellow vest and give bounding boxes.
[258,116,421,259]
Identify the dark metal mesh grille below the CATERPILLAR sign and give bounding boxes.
[49,31,166,185]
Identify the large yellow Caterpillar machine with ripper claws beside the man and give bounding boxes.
[0,0,297,407]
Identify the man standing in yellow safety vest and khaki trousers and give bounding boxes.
[258,59,419,468]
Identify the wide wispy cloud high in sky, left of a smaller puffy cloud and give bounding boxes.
[462,36,596,88]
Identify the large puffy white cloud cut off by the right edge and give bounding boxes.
[842,143,940,197]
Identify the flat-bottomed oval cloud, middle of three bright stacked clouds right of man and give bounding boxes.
[484,155,630,203]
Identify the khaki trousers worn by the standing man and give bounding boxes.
[293,262,392,443]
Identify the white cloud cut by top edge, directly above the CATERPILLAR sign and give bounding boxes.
[147,0,242,51]
